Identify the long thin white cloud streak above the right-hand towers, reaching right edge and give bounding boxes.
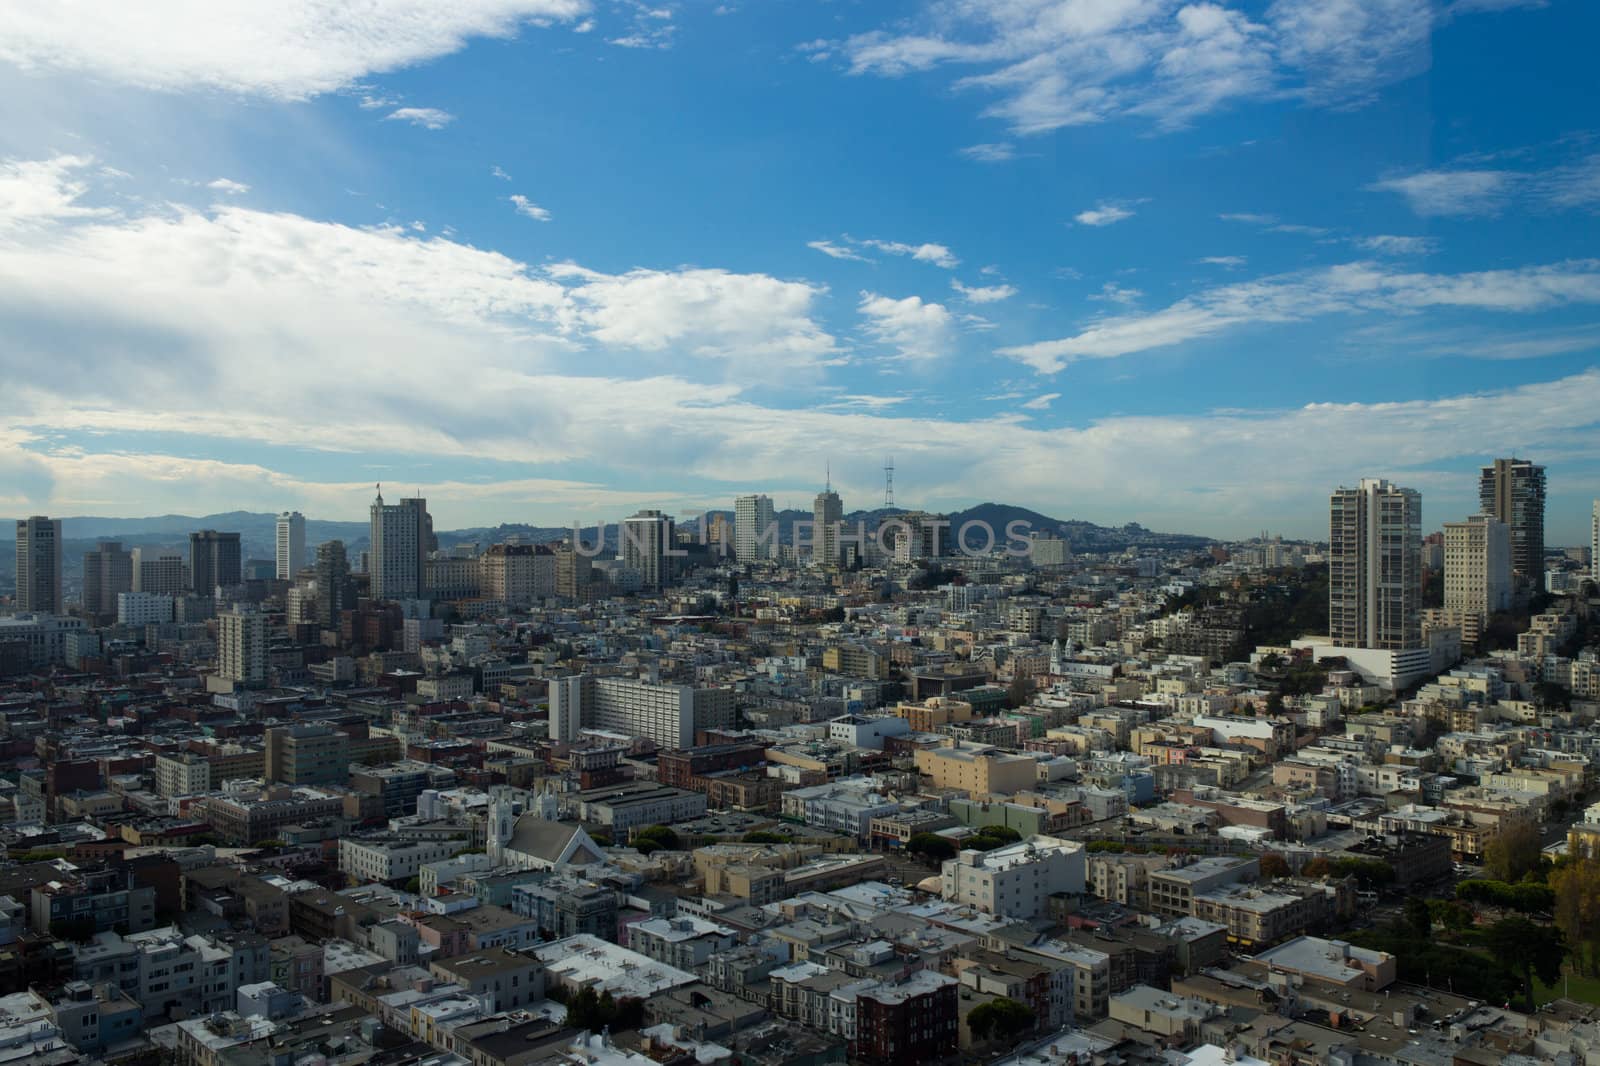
[997,259,1600,373]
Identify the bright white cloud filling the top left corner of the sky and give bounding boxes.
[0,0,589,99]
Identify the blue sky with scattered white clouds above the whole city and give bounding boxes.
[0,0,1600,543]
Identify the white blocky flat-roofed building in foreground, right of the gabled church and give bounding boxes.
[939,837,1088,919]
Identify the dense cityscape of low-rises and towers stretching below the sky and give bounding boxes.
[0,458,1600,1066]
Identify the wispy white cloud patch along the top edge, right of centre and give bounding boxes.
[838,0,1510,136]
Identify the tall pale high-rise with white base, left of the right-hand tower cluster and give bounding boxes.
[1328,477,1422,650]
